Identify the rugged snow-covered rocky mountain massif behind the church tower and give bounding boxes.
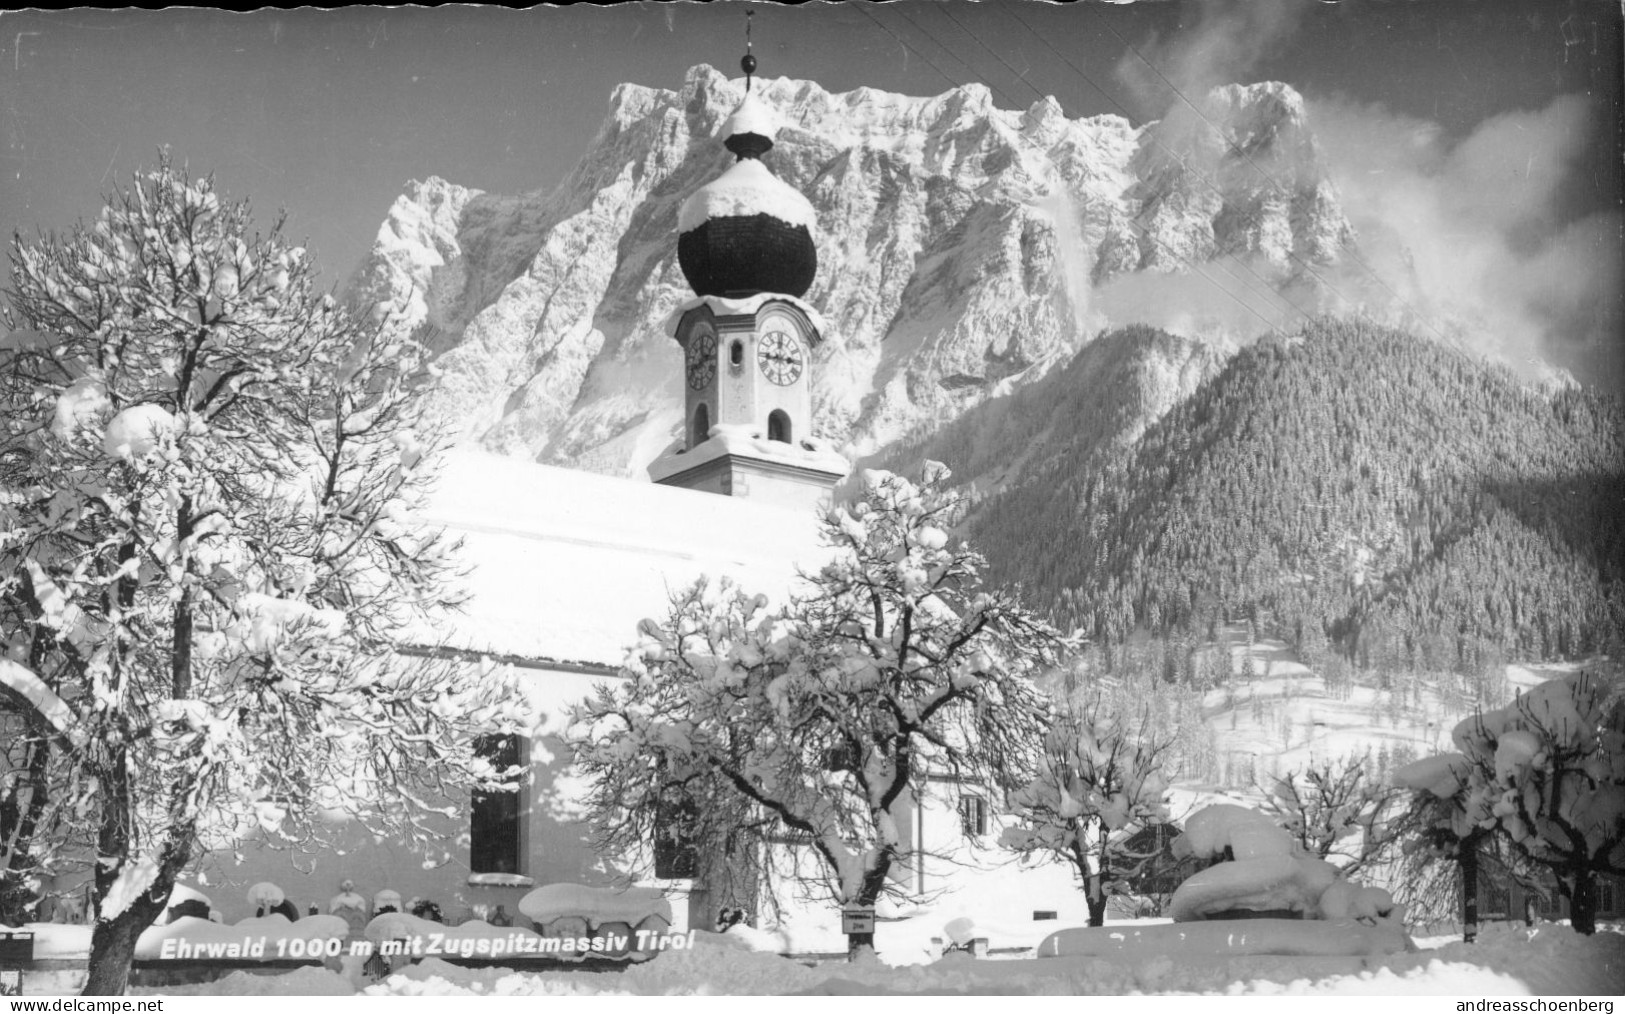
[354,67,1352,476]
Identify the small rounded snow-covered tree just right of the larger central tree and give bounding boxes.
[999,697,1168,926]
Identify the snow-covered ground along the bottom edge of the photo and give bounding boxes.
[120,923,1625,996]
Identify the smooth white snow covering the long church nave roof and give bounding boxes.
[412,450,829,666]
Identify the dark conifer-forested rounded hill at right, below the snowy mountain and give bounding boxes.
[939,320,1625,673]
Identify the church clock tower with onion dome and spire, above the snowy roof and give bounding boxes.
[648,43,848,509]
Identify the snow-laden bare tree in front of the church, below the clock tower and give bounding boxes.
[574,466,1064,947]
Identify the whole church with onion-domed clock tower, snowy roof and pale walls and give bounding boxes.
[205,57,1084,941]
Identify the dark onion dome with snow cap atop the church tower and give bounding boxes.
[678,91,817,297]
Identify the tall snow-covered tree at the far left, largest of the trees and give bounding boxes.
[0,161,528,993]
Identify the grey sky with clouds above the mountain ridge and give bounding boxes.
[0,0,1625,385]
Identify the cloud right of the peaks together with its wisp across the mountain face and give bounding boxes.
[1090,84,1625,390]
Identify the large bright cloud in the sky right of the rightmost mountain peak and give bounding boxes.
[1308,96,1625,385]
